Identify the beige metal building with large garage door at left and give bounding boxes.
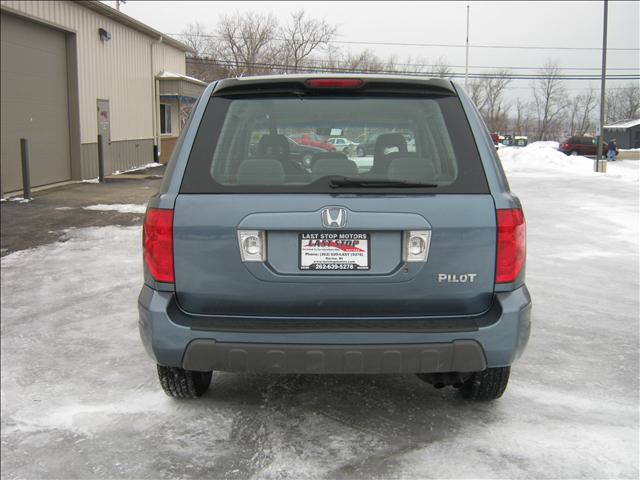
[0,0,204,193]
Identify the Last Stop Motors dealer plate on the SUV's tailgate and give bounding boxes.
[298,232,371,271]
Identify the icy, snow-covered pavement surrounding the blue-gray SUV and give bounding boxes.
[1,147,639,479]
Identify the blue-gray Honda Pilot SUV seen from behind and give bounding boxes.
[138,75,531,400]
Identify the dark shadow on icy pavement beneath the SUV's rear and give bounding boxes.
[201,373,504,478]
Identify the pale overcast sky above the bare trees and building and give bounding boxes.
[105,0,640,95]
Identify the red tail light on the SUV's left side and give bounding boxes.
[142,208,174,283]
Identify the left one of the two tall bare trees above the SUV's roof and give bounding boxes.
[214,12,278,76]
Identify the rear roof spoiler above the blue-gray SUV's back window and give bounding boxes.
[212,73,456,95]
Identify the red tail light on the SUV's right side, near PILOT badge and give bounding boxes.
[496,208,526,283]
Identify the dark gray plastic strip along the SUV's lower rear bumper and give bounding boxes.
[182,340,487,373]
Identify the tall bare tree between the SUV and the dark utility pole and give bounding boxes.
[533,60,567,140]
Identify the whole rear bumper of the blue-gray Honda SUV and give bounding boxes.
[138,285,531,373]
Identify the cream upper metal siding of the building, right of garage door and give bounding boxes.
[0,0,185,154]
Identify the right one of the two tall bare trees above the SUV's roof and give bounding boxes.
[279,10,337,71]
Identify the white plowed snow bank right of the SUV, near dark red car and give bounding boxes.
[498,142,640,183]
